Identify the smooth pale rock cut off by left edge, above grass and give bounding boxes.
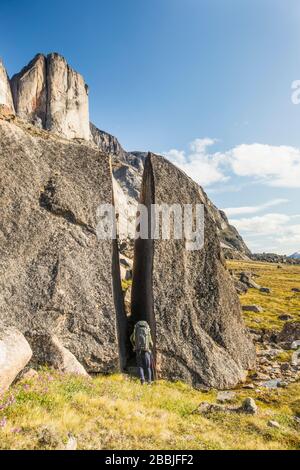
[0,326,32,395]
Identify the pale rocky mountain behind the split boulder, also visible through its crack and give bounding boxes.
[7,53,250,258]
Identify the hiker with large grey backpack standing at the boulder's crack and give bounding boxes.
[130,321,154,385]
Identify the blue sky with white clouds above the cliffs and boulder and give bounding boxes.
[0,0,300,254]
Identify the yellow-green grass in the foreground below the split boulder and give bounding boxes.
[0,370,300,450]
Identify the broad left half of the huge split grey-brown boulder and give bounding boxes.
[0,119,126,372]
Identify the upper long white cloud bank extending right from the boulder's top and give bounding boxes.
[164,137,300,188]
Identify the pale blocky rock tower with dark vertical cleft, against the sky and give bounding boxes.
[11,53,90,140]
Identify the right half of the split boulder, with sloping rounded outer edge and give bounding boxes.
[132,154,255,388]
